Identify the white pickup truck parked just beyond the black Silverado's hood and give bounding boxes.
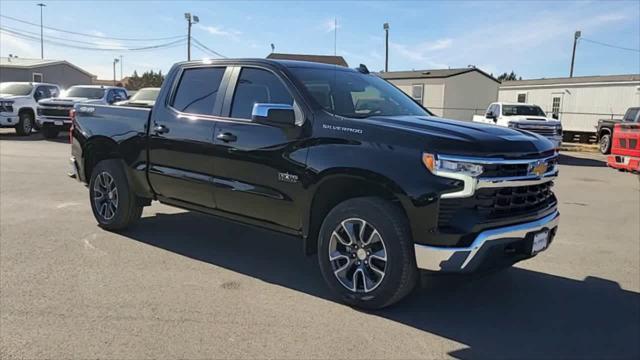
[473,102,562,149]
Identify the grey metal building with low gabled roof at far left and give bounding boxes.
[0,56,96,88]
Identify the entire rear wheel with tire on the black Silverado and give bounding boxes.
[89,159,142,231]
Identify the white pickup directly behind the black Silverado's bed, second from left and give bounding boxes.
[36,85,128,139]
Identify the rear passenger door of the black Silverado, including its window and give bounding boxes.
[149,66,227,208]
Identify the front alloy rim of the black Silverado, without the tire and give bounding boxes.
[329,218,387,293]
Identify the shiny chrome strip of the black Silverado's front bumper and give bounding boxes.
[414,211,560,273]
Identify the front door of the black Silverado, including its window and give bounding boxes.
[214,67,307,229]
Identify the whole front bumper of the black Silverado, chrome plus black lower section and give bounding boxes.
[414,211,560,273]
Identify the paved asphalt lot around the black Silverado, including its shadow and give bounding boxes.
[0,130,640,359]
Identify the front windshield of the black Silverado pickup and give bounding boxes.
[291,68,430,118]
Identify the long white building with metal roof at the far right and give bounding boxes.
[498,74,640,140]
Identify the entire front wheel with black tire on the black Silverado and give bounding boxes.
[318,197,418,310]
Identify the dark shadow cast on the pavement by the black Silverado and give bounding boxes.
[123,212,640,359]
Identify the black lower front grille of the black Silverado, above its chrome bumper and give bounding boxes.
[438,181,557,228]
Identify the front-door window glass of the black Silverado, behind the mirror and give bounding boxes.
[231,68,293,119]
